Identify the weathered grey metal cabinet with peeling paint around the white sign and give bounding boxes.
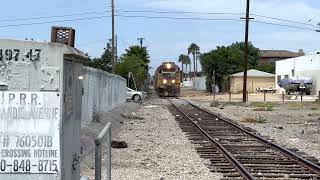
[0,40,85,180]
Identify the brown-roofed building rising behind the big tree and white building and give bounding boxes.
[259,49,305,64]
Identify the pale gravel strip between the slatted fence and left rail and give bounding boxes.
[83,98,221,180]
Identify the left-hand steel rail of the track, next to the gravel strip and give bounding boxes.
[168,100,256,180]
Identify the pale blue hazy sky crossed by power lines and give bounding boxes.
[0,0,320,74]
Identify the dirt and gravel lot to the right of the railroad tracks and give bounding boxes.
[183,88,320,160]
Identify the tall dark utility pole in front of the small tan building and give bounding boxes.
[241,0,253,102]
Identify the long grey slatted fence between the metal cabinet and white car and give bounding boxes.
[81,67,126,127]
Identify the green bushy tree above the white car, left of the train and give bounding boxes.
[115,46,150,90]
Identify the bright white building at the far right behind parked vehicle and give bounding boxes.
[276,52,320,95]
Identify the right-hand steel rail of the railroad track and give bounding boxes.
[178,98,320,176]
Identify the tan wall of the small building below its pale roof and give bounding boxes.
[230,77,275,93]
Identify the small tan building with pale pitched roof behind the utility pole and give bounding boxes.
[230,69,275,93]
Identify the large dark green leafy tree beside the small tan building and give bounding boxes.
[200,42,260,91]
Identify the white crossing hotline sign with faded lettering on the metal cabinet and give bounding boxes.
[0,91,60,173]
